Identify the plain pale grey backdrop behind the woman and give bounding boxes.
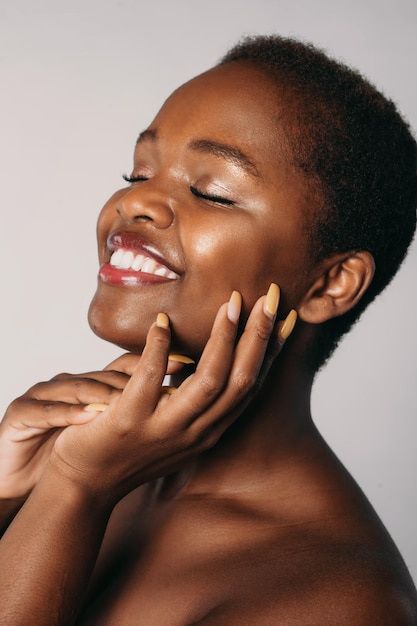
[0,0,417,580]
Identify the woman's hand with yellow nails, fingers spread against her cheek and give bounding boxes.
[51,286,295,506]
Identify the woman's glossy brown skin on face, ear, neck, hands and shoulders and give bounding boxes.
[0,63,417,626]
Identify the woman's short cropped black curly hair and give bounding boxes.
[219,35,417,370]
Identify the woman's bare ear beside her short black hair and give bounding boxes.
[298,251,375,324]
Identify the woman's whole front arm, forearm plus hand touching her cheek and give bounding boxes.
[0,288,292,626]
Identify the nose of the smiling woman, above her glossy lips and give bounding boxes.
[116,181,174,228]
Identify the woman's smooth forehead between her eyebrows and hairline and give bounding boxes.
[150,63,288,177]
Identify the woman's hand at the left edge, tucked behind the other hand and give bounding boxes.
[0,354,135,499]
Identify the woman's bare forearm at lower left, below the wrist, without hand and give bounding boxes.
[0,470,110,626]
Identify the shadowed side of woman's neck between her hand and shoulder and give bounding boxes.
[173,336,316,494]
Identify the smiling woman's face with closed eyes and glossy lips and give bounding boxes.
[89,63,316,357]
